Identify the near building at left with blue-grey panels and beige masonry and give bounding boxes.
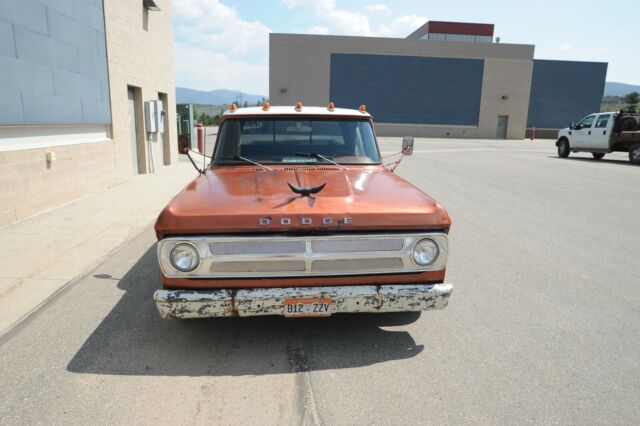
[0,0,178,226]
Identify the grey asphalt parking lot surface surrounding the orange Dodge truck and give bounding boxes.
[0,138,640,425]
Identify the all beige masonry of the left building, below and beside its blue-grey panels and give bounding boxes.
[0,0,178,226]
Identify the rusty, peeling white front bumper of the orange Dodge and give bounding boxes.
[153,284,453,319]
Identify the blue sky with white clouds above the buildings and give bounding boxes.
[172,0,640,96]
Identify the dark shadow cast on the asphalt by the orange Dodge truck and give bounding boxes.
[67,245,424,376]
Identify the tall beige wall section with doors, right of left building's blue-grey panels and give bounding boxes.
[104,0,178,179]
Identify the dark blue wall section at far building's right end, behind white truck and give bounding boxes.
[527,59,607,129]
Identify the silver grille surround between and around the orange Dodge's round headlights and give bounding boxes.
[158,232,448,278]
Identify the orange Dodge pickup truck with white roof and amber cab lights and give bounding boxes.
[154,103,453,318]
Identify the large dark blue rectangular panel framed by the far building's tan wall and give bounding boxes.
[330,53,484,126]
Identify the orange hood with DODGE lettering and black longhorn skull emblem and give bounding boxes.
[155,166,451,238]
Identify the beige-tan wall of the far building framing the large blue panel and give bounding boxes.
[269,34,534,139]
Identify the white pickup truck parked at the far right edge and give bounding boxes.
[556,112,640,164]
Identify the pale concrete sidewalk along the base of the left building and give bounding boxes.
[0,156,197,335]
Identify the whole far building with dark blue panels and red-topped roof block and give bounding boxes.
[269,21,607,139]
